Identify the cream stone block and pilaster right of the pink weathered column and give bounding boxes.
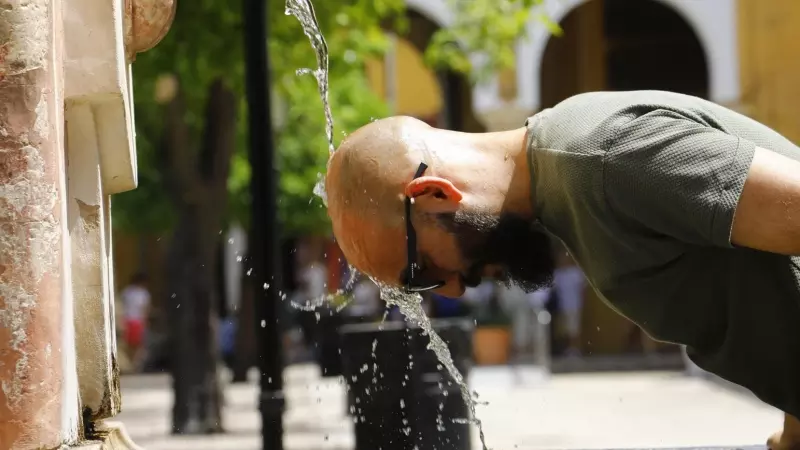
[64,0,176,428]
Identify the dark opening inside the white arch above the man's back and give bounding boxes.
[539,0,709,108]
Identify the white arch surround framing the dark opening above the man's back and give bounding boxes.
[516,0,740,111]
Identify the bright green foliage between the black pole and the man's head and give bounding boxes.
[262,0,403,234]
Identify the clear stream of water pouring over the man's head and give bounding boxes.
[286,0,487,450]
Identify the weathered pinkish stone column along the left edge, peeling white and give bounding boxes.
[0,0,78,449]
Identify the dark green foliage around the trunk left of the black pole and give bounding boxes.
[113,0,246,233]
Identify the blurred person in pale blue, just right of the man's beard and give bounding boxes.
[553,252,586,356]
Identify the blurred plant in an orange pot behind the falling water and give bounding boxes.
[472,290,512,365]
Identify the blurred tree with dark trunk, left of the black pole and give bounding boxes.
[122,1,242,433]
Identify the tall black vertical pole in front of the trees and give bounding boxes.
[242,0,285,450]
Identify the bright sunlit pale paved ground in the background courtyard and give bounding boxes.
[118,365,782,450]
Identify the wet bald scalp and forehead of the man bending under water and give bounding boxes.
[325,117,437,282]
